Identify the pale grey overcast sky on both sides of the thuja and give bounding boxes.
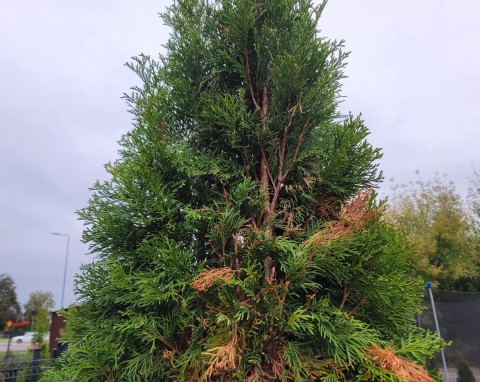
[0,0,480,306]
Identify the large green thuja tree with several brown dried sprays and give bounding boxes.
[44,0,441,382]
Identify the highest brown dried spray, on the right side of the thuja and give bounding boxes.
[307,190,381,245]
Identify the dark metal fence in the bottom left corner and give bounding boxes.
[0,351,53,382]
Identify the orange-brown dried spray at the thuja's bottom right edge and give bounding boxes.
[366,346,435,382]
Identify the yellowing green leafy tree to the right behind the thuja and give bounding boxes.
[388,177,479,290]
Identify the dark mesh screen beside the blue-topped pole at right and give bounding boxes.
[420,290,480,382]
